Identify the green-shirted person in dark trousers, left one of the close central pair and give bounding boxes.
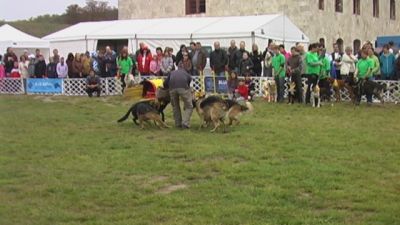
[306,43,322,104]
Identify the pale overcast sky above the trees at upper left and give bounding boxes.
[0,0,118,21]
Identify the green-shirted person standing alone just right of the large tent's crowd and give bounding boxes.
[272,45,286,103]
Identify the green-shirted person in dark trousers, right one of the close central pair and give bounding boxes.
[319,48,331,101]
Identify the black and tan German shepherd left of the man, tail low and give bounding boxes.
[118,100,169,129]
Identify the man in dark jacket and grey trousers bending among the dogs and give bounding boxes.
[164,67,193,129]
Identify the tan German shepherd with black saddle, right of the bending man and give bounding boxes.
[194,96,253,132]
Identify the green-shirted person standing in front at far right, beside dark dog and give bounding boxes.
[355,49,374,105]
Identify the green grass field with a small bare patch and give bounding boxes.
[0,96,400,225]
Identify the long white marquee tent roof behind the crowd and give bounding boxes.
[43,14,309,55]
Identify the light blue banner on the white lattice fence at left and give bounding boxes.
[26,78,63,94]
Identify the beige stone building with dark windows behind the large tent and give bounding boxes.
[119,0,400,49]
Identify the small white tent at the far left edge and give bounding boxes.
[0,24,49,59]
